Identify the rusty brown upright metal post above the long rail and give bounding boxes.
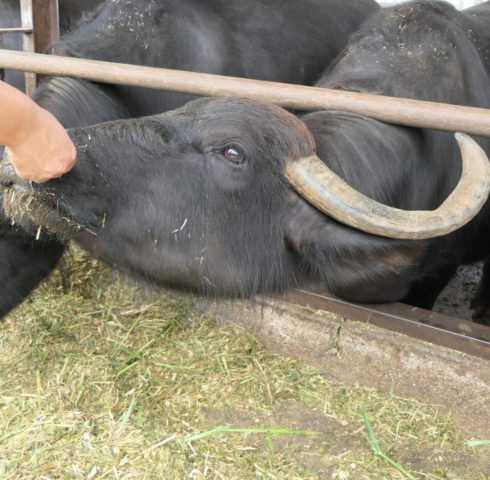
[32,0,60,53]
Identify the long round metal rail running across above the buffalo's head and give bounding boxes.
[0,50,490,137]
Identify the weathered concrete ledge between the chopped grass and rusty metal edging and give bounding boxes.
[196,298,490,438]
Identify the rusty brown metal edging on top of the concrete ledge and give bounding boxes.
[277,290,490,360]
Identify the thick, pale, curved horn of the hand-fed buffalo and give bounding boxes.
[285,133,490,240]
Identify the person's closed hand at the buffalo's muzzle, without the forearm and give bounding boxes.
[5,107,77,183]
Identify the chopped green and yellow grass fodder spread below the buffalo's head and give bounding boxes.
[0,250,490,480]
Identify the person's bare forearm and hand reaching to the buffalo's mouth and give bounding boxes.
[0,81,76,183]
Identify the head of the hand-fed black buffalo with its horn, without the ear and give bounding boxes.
[0,98,490,295]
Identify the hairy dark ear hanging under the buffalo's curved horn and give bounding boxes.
[285,193,423,303]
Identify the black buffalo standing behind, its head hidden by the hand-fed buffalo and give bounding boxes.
[0,0,379,317]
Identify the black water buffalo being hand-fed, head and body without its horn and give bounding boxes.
[3,1,490,322]
